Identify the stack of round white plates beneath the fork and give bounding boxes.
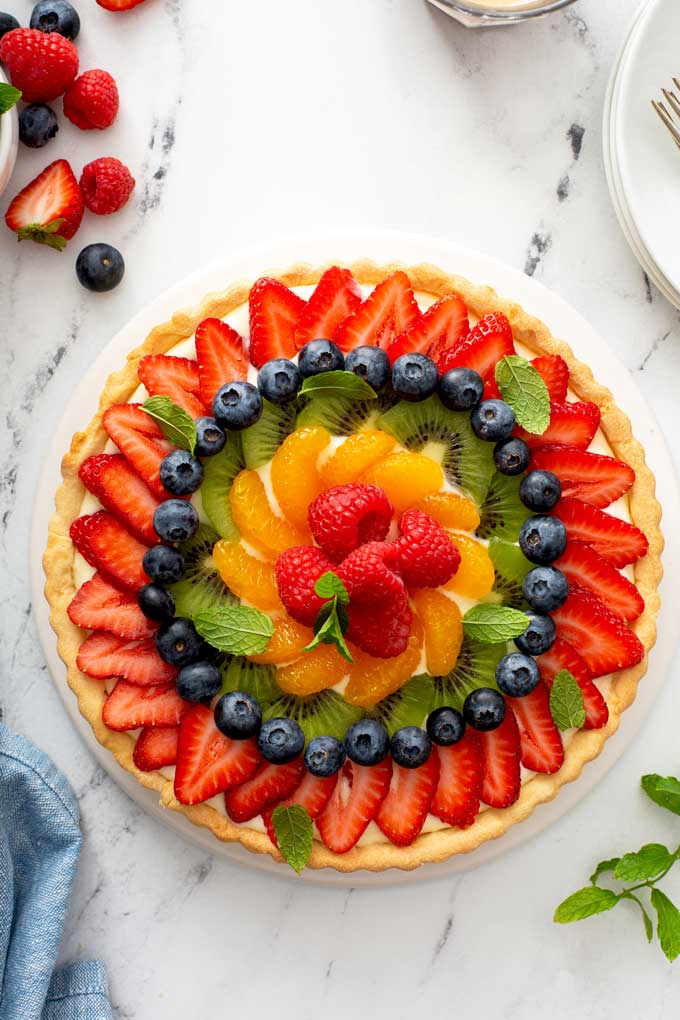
[603,0,680,308]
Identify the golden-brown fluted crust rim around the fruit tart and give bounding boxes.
[43,260,664,872]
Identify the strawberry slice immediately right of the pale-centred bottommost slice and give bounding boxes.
[375,752,439,847]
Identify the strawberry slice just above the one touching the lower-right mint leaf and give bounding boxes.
[551,585,644,676]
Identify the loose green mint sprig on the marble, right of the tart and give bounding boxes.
[553,774,680,963]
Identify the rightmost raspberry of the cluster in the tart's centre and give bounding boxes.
[393,510,461,588]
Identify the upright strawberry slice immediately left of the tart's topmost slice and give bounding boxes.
[249,276,306,368]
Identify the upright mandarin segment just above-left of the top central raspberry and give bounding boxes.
[271,425,330,541]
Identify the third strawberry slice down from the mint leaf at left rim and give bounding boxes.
[69,510,151,592]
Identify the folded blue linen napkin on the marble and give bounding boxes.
[0,725,113,1020]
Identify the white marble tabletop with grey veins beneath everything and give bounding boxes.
[0,0,680,1020]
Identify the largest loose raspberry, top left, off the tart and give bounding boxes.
[0,29,79,103]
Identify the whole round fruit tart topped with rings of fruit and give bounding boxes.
[44,261,663,871]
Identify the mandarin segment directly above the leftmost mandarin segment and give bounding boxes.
[229,470,306,559]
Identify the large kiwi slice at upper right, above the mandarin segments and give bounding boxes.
[376,395,494,504]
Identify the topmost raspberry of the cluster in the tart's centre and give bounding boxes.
[308,483,394,560]
